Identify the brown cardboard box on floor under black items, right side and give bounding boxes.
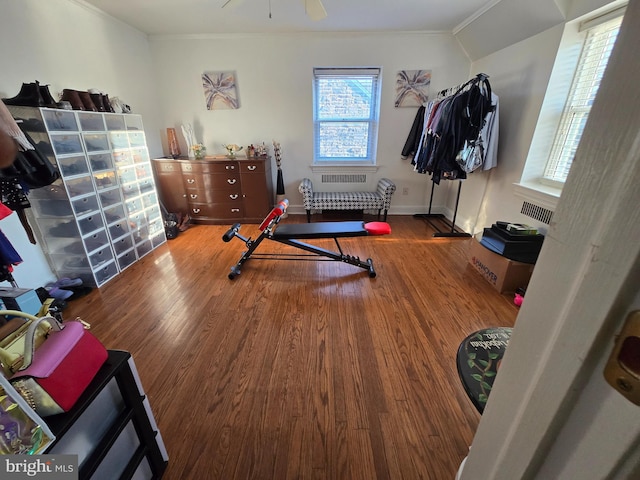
[469,239,534,293]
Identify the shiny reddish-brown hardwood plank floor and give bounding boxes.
[63,216,517,480]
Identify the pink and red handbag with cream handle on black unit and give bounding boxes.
[9,316,108,417]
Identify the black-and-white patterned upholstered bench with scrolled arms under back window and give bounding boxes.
[298,178,396,222]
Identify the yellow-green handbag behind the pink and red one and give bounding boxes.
[0,310,51,377]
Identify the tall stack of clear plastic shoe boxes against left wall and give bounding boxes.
[8,106,166,287]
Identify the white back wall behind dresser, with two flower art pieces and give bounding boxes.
[150,33,469,213]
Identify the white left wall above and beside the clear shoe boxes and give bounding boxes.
[0,0,161,288]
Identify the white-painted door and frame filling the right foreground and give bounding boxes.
[461,0,640,480]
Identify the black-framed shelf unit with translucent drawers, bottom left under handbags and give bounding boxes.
[44,350,168,480]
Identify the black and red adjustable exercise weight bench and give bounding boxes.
[222,200,391,280]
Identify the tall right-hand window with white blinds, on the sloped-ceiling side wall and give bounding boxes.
[543,16,622,186]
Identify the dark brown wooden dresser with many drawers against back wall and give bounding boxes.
[152,156,275,224]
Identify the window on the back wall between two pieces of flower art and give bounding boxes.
[313,68,380,165]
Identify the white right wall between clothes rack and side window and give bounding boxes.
[457,25,563,233]
